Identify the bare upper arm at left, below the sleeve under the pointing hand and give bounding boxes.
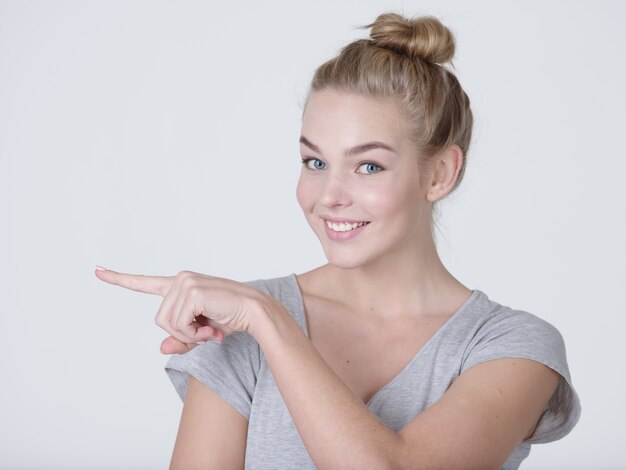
[170,375,248,470]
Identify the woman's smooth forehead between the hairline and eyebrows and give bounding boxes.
[302,90,406,146]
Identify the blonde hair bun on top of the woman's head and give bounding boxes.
[363,13,454,64]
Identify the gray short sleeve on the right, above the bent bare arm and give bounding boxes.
[461,309,581,444]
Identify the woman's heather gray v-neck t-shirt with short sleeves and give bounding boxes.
[165,274,580,470]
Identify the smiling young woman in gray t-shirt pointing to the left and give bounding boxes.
[97,13,580,469]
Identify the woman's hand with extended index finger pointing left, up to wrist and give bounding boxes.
[96,269,267,354]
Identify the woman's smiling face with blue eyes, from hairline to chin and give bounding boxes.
[296,90,431,269]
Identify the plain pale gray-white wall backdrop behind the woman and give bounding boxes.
[0,0,626,469]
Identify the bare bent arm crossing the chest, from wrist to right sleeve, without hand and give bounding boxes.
[249,300,560,469]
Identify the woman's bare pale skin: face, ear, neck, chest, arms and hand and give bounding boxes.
[96,91,560,469]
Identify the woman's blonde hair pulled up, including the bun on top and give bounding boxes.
[303,12,473,239]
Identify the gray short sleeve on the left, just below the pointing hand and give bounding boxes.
[165,281,261,420]
